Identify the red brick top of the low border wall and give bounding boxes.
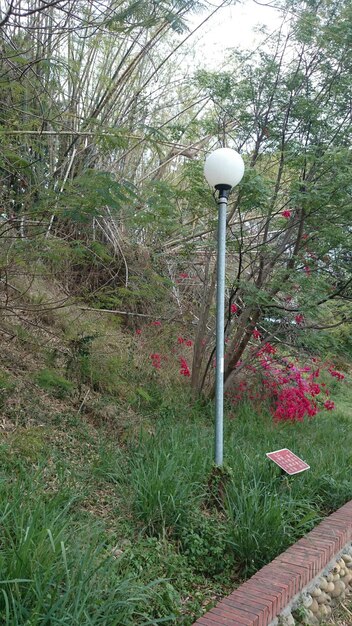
[194,500,352,626]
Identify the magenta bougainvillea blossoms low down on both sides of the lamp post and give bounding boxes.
[132,320,345,421]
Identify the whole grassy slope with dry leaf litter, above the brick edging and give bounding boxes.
[0,283,352,626]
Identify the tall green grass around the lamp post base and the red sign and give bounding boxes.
[113,394,352,575]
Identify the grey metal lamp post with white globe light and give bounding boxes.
[204,148,244,465]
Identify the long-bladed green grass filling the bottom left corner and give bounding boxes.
[0,466,175,626]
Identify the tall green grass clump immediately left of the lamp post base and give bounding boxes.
[110,420,211,536]
